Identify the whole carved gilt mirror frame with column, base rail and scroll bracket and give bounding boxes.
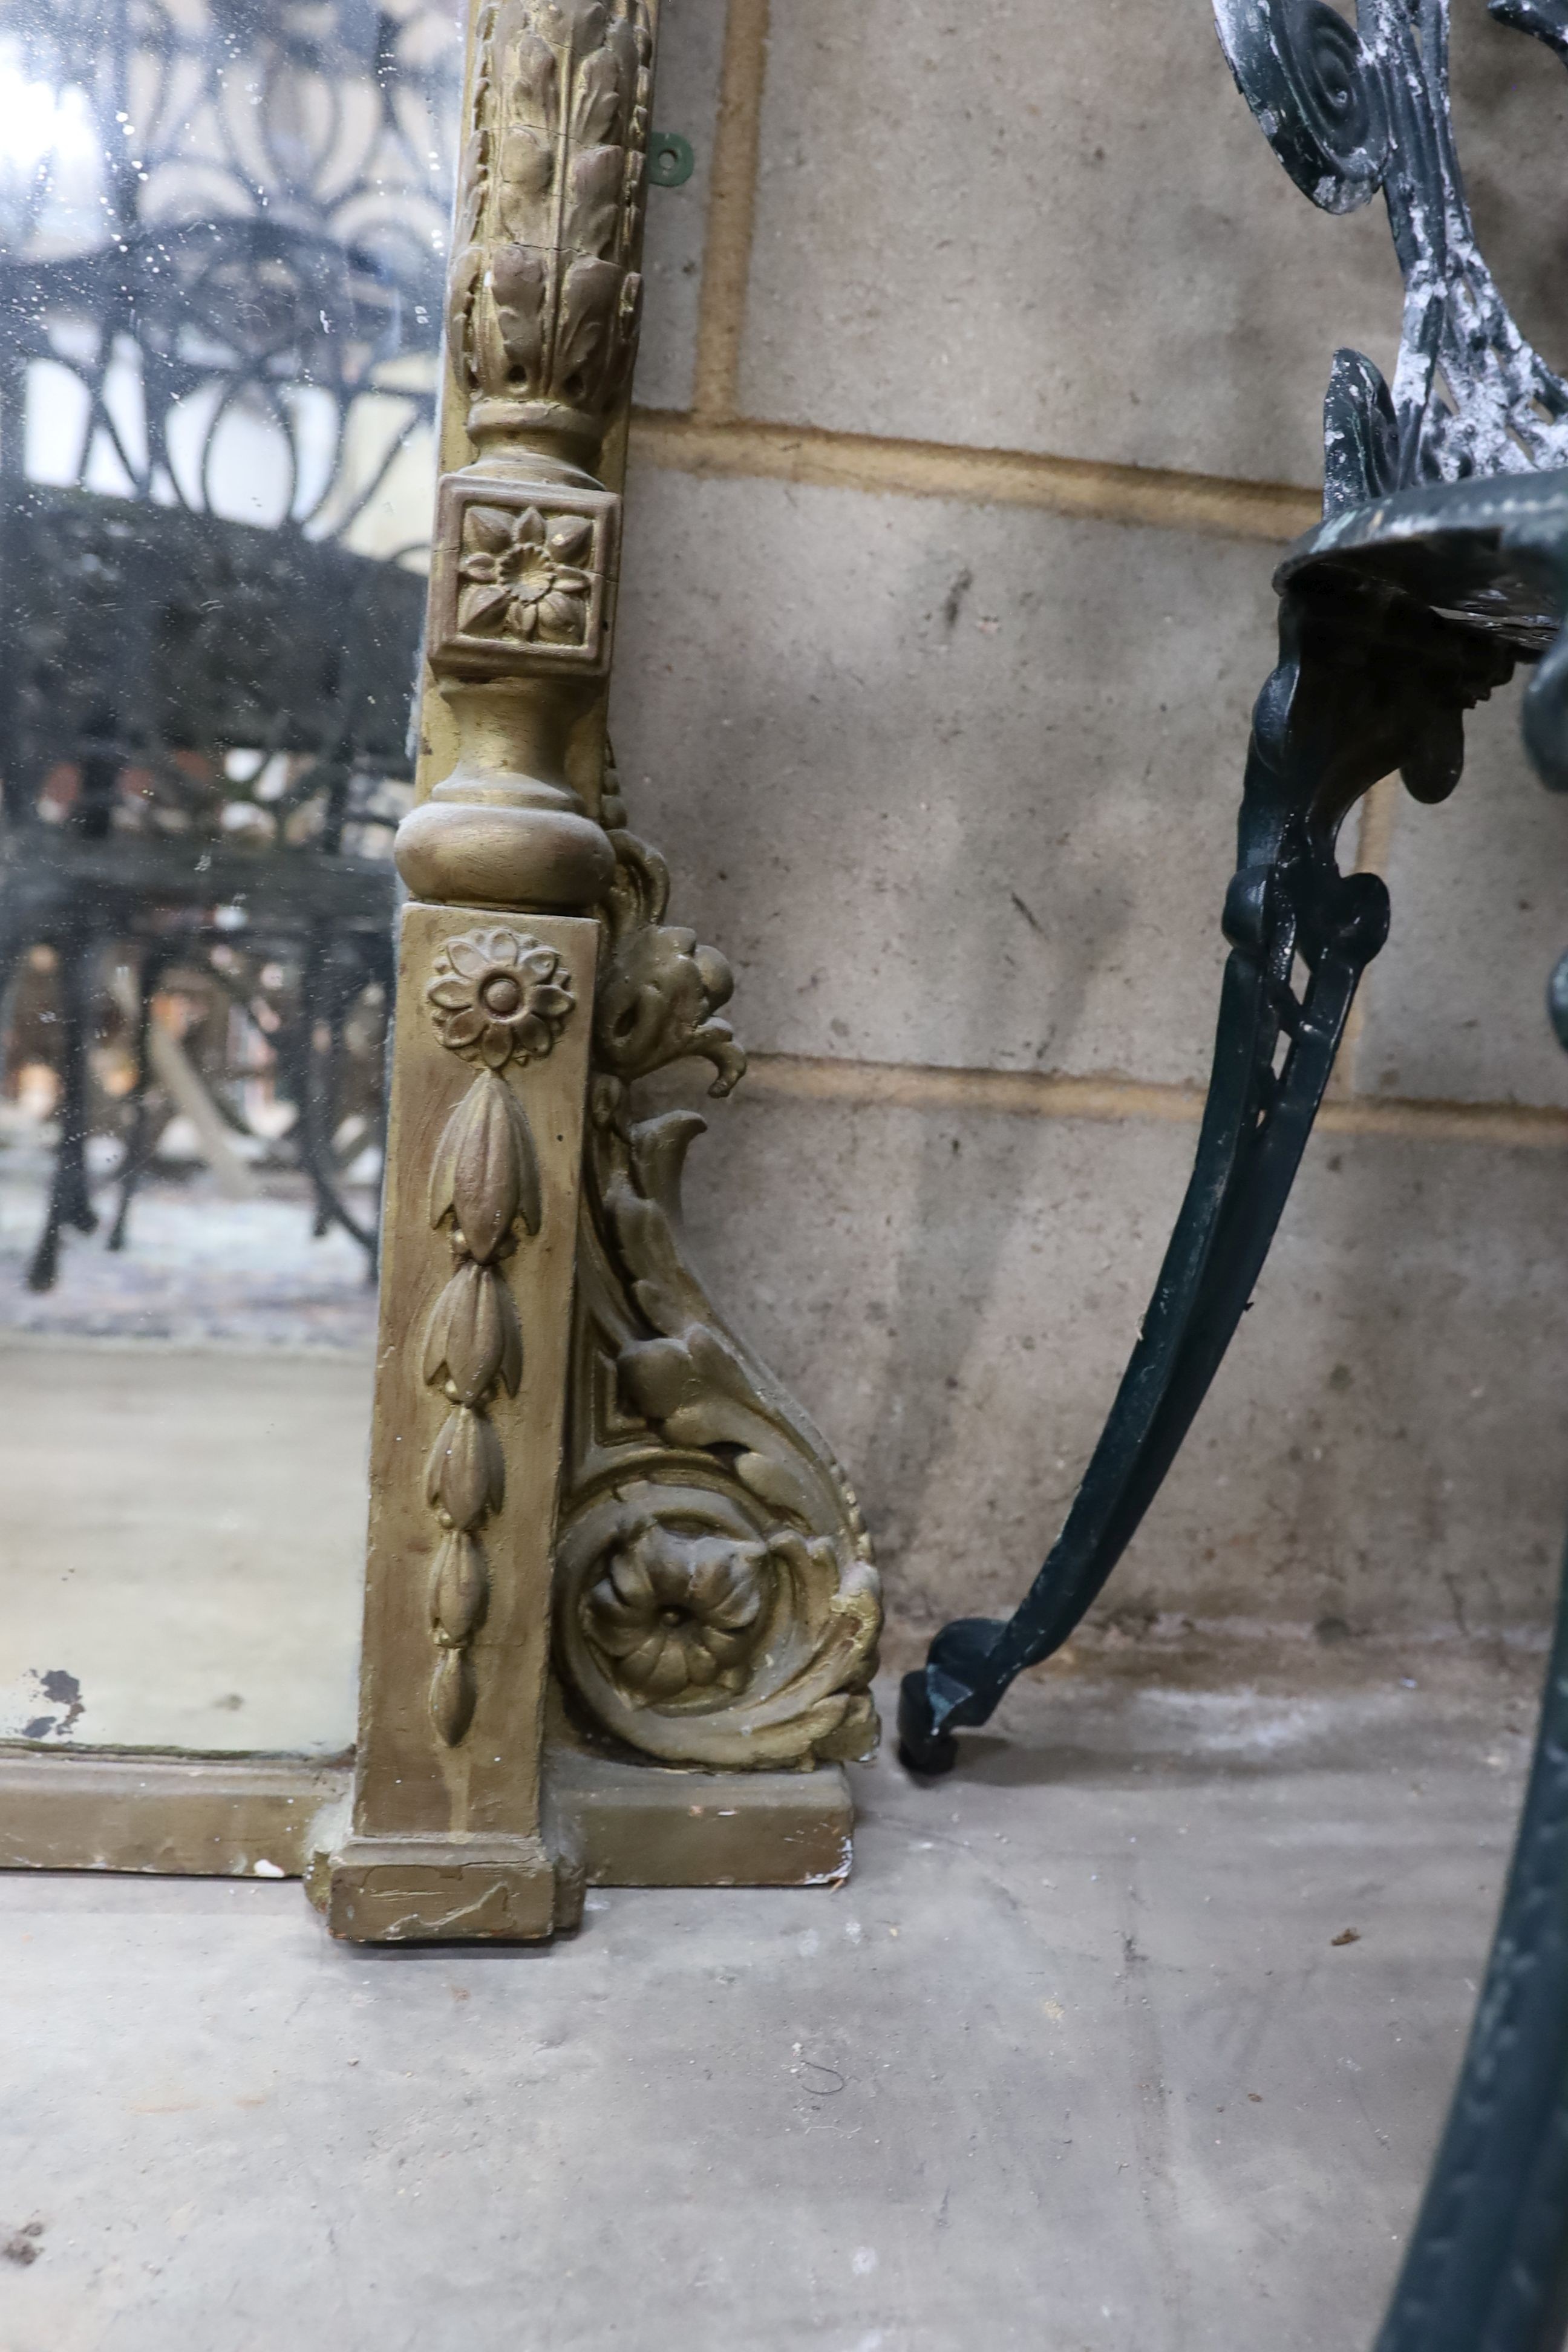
[0,0,879,1941]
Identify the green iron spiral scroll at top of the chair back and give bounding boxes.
[1215,0,1390,212]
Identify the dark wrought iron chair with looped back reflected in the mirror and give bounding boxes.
[0,0,461,1287]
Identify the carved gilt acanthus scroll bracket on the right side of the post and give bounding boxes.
[555,779,881,1769]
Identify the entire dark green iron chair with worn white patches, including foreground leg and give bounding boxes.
[900,0,1568,2352]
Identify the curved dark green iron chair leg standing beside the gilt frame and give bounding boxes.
[898,578,1514,1774]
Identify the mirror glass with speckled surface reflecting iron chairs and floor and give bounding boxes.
[0,0,461,1753]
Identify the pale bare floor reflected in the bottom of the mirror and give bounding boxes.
[0,1345,371,1749]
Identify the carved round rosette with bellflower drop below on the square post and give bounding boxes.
[421,927,573,1748]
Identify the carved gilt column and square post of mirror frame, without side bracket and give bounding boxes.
[329,0,653,1938]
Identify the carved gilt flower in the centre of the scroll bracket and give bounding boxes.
[583,1522,769,1705]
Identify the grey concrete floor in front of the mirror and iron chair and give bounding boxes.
[0,1644,1540,2352]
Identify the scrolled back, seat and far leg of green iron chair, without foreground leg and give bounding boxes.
[900,0,1568,1771]
